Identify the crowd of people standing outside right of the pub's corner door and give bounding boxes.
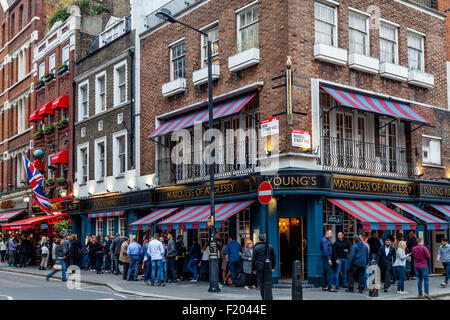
[320,230,450,299]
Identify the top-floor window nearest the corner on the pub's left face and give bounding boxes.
[237,5,259,52]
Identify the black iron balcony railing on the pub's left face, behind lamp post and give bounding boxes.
[154,140,258,186]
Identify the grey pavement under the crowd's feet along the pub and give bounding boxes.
[0,264,450,300]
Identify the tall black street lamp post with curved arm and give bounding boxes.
[156,8,220,292]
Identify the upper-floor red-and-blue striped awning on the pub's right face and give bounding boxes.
[321,86,429,123]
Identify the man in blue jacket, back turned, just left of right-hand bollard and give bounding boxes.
[346,236,369,293]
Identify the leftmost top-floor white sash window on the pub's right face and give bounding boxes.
[314,2,337,47]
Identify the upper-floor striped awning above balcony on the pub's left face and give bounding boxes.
[147,93,256,138]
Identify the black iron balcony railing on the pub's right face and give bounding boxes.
[319,137,414,178]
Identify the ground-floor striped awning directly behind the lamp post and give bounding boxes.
[158,200,255,230]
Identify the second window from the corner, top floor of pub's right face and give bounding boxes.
[348,12,369,56]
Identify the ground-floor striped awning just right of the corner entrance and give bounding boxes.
[327,199,416,230]
